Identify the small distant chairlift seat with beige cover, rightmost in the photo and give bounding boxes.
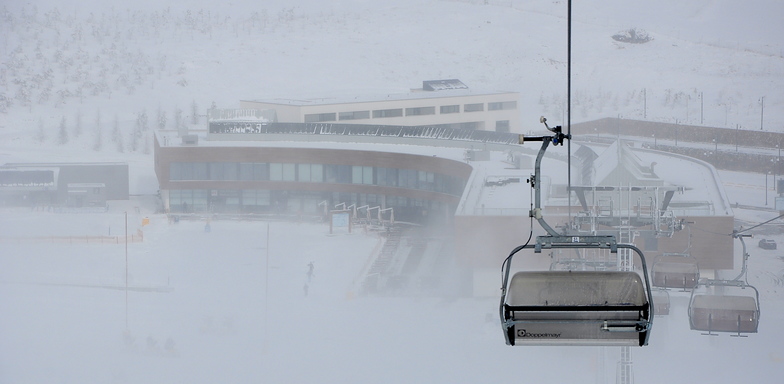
[689,286,760,335]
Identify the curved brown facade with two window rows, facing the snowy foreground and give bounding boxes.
[155,124,472,223]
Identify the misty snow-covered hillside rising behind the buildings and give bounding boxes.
[0,0,784,170]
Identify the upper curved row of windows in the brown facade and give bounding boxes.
[169,162,464,196]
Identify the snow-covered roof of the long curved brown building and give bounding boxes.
[156,123,731,216]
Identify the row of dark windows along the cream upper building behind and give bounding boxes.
[304,101,517,123]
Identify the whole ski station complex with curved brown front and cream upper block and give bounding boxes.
[154,81,740,296]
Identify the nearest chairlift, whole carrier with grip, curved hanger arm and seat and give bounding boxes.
[499,117,654,346]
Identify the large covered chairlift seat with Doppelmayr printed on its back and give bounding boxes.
[503,271,653,346]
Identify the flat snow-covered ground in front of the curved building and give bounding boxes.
[0,185,784,383]
